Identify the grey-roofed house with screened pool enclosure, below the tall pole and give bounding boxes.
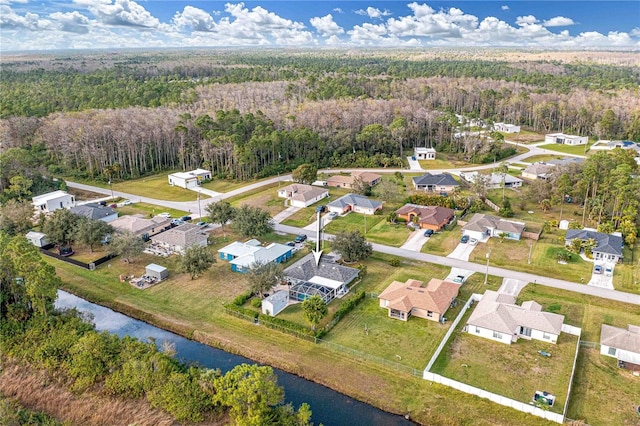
[284,253,360,303]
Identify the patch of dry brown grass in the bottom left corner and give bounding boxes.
[0,359,178,426]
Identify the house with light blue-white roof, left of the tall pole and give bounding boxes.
[218,239,293,273]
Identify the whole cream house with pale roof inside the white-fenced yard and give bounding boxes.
[466,290,564,345]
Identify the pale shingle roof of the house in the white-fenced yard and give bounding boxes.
[467,290,564,335]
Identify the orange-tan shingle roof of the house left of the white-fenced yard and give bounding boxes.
[378,278,460,314]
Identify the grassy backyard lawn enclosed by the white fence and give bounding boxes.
[431,322,578,413]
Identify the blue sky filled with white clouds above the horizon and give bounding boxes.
[0,0,640,52]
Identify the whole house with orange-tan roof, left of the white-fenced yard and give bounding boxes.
[378,278,460,321]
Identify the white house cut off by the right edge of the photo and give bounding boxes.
[600,324,640,371]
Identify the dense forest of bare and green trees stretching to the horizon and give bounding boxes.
[0,51,640,181]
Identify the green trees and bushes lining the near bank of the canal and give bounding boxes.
[0,232,311,426]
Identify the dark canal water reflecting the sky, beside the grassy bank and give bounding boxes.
[56,290,413,426]
